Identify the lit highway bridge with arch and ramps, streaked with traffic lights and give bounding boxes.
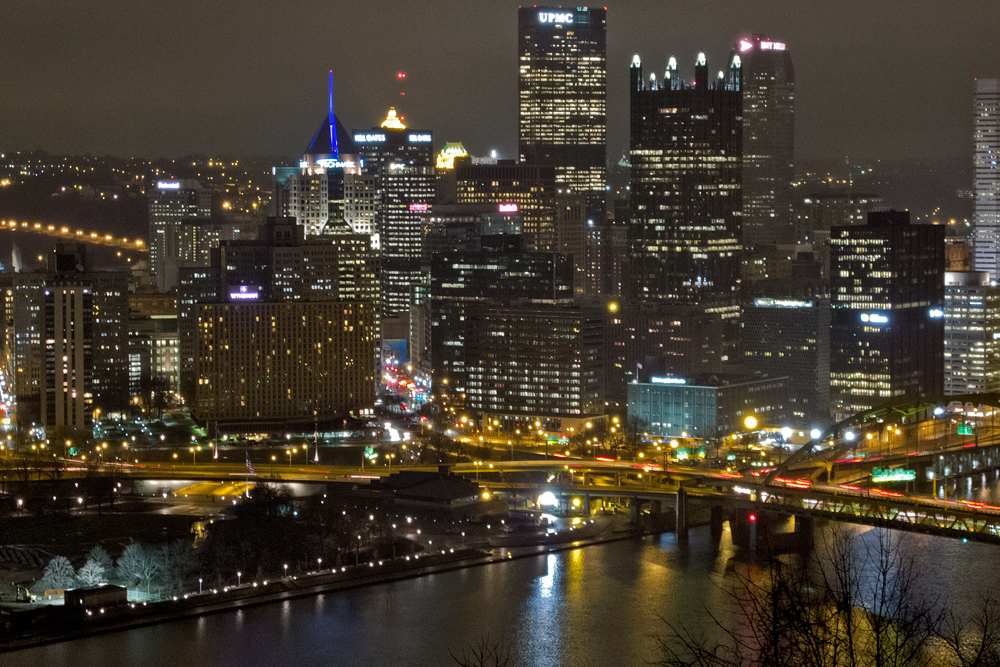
[9,394,1000,543]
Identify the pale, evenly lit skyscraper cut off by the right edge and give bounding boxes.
[972,79,1000,280]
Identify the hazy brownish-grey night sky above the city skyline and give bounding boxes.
[0,0,1000,161]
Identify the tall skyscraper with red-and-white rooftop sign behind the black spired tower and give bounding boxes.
[736,35,795,246]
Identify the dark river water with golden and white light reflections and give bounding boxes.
[11,525,1000,667]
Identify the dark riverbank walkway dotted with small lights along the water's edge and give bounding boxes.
[0,518,668,652]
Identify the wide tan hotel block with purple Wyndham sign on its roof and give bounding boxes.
[193,302,377,430]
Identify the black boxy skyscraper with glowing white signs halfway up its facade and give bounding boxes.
[830,211,945,421]
